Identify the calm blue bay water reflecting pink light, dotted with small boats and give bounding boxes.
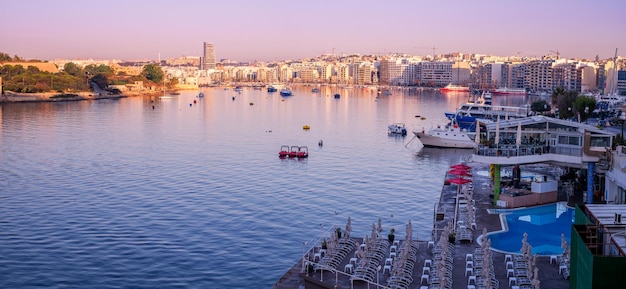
[0,87,527,288]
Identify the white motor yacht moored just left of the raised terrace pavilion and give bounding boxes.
[413,125,476,149]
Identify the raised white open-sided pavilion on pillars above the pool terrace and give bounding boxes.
[472,116,615,206]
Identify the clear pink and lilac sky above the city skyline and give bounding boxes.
[0,0,626,62]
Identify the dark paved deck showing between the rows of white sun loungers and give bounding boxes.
[272,165,569,289]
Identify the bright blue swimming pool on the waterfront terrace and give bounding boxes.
[488,203,574,255]
